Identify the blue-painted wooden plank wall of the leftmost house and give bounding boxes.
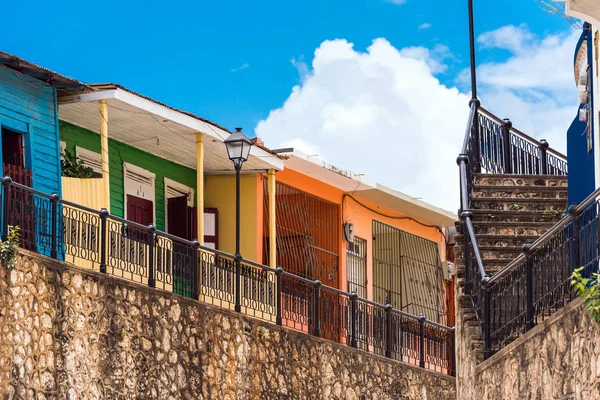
[0,66,62,195]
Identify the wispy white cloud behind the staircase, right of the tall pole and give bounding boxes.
[468,25,581,151]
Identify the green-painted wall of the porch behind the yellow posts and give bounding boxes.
[60,121,196,231]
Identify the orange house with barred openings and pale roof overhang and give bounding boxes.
[257,149,456,324]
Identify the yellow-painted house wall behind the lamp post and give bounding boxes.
[204,174,263,261]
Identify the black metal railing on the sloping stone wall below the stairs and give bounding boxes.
[483,190,600,354]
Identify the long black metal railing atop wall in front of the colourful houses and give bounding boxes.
[0,177,455,375]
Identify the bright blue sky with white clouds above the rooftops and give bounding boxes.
[0,0,578,209]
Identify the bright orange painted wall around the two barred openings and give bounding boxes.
[277,169,446,299]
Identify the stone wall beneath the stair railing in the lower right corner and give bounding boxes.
[464,299,600,400]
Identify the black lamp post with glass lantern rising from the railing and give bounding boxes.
[224,128,252,312]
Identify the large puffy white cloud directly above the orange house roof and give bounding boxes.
[256,39,468,210]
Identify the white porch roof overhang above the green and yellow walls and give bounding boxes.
[59,85,283,171]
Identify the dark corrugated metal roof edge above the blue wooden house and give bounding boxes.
[0,51,93,95]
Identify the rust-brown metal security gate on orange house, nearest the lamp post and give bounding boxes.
[263,179,341,288]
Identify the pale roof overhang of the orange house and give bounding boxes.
[273,148,458,228]
